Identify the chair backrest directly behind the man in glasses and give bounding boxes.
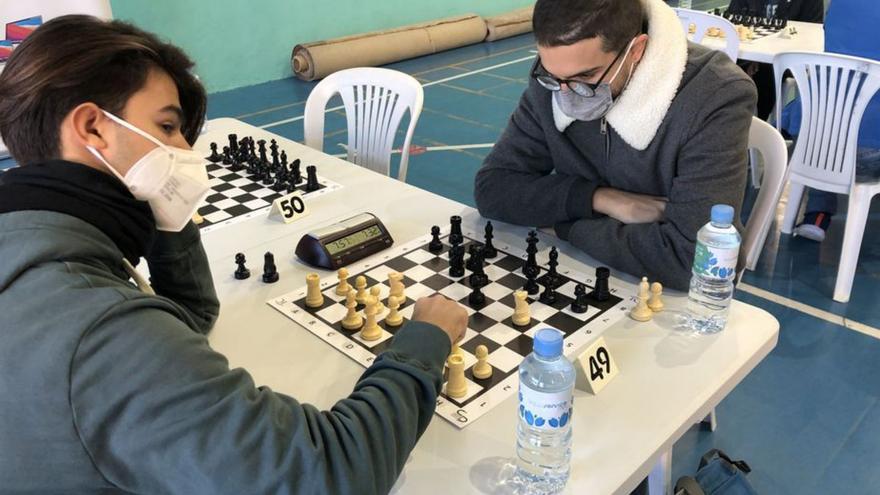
[743,117,788,276]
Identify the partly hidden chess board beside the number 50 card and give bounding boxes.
[199,162,342,232]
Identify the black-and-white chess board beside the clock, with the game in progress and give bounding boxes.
[267,227,638,428]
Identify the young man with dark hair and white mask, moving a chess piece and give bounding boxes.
[0,16,467,494]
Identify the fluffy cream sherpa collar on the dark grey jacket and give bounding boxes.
[550,0,687,150]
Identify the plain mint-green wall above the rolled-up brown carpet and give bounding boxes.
[110,0,533,92]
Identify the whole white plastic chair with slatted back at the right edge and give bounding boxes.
[773,52,880,302]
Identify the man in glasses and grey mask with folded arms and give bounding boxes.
[475,0,756,290]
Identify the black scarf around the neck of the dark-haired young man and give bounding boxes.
[0,160,156,265]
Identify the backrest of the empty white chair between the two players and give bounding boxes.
[303,67,425,181]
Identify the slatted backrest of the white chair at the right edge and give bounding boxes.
[773,52,880,193]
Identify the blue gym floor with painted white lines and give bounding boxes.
[0,35,880,495]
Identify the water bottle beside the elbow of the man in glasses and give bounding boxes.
[687,205,742,333]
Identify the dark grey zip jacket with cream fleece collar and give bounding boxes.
[475,0,757,290]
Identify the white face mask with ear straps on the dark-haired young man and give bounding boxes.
[86,110,211,232]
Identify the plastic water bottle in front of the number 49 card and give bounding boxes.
[516,328,576,495]
